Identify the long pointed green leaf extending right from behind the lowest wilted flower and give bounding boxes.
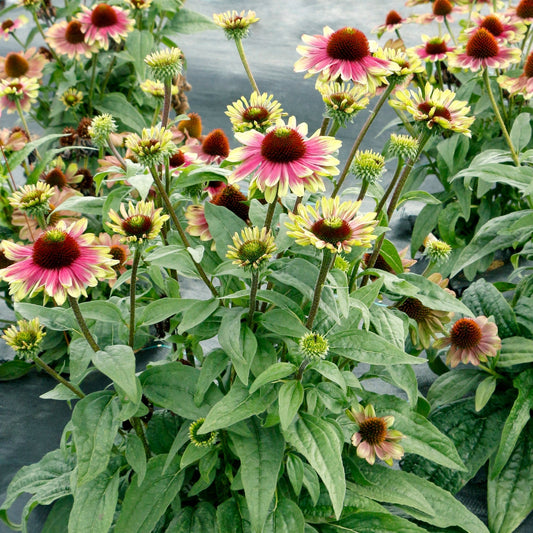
[365,393,466,471]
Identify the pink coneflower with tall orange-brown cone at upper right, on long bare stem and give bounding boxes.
[449,28,521,71]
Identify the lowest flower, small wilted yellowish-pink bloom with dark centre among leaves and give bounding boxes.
[348,404,404,466]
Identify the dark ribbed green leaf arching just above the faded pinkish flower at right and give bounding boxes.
[462,279,520,339]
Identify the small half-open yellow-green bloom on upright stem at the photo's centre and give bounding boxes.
[226,226,277,269]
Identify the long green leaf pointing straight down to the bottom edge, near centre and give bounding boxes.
[231,418,285,533]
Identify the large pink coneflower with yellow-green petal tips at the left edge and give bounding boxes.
[0,219,115,305]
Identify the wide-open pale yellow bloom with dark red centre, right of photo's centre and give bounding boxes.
[285,196,377,253]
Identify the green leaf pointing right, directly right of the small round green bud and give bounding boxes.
[328,329,424,365]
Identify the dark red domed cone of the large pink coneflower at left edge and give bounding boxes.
[32,229,81,270]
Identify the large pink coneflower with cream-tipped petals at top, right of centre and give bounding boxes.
[294,26,393,86]
